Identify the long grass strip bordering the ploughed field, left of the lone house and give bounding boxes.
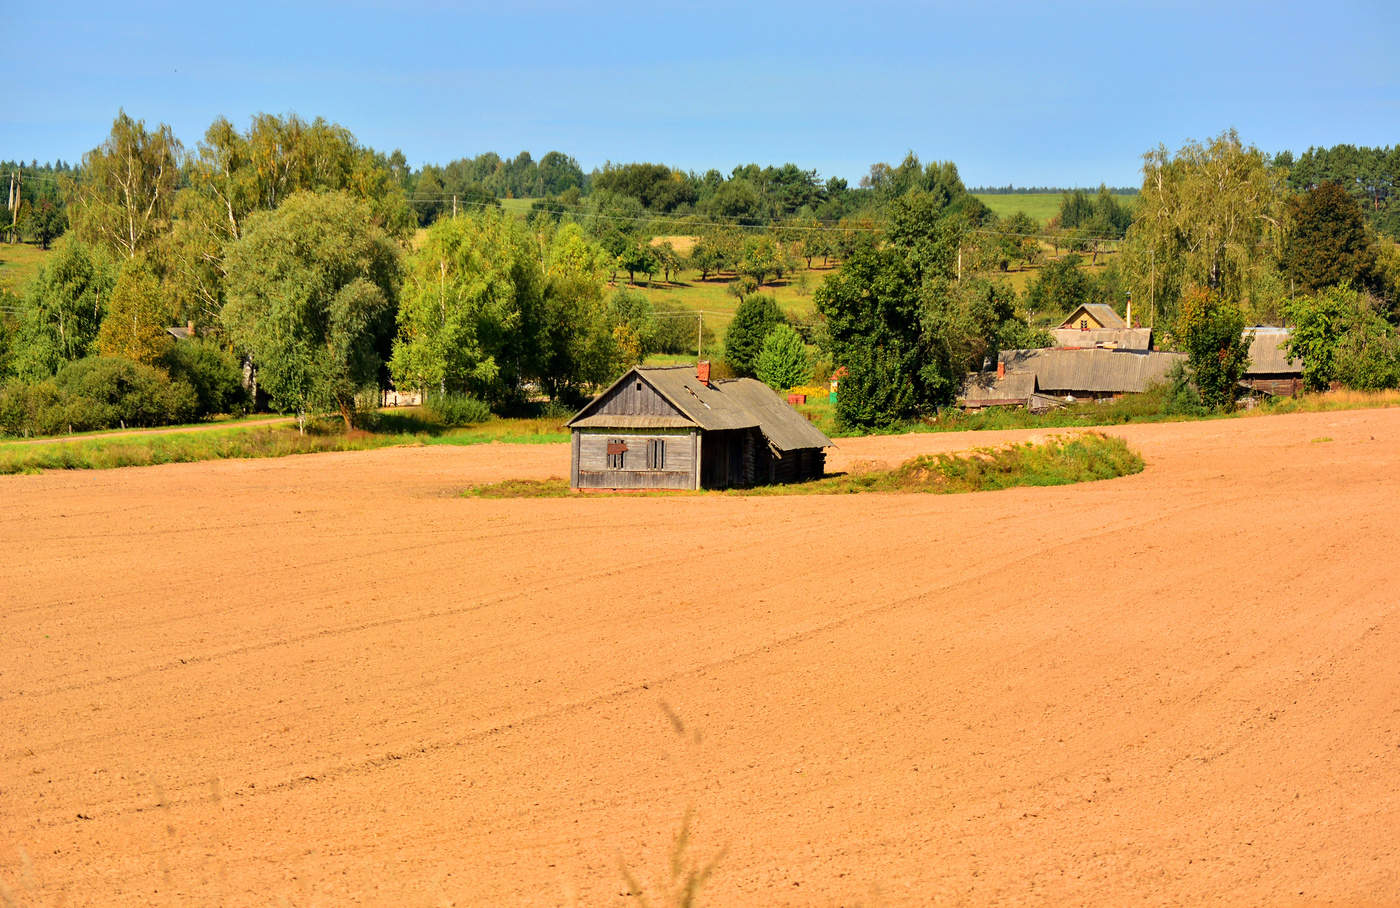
[0,411,568,476]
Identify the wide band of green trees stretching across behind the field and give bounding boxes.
[0,113,1400,432]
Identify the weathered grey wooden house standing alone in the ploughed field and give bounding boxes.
[568,362,832,488]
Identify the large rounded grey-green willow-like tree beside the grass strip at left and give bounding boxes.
[223,192,399,431]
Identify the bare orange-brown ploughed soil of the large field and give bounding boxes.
[0,410,1400,905]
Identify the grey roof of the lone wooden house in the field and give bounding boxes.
[568,365,832,451]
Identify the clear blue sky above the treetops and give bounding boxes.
[0,0,1400,186]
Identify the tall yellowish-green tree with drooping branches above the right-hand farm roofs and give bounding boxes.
[1123,130,1287,324]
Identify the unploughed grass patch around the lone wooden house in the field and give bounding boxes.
[462,432,1142,498]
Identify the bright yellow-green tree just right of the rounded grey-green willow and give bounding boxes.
[392,210,551,407]
